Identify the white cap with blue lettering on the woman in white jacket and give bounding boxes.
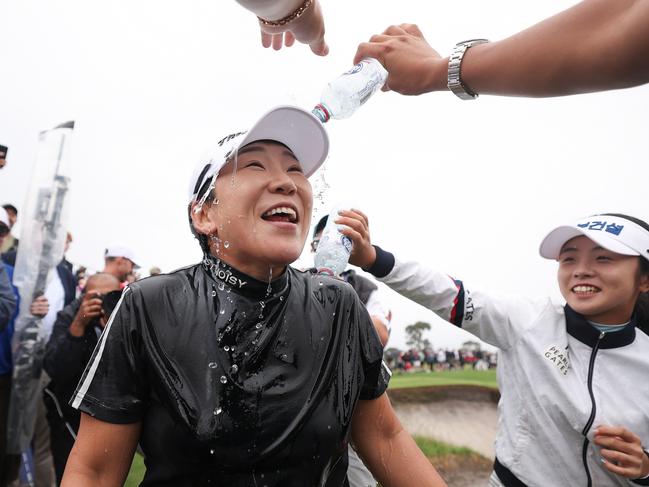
[539,214,649,260]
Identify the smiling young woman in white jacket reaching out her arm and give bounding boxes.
[336,210,649,487]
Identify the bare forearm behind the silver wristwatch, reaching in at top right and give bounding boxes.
[462,0,649,97]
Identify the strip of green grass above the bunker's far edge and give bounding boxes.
[390,369,498,389]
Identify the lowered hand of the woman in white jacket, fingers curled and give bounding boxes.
[595,426,649,479]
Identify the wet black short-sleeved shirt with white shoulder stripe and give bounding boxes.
[73,261,388,487]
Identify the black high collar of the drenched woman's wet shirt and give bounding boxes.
[203,255,288,299]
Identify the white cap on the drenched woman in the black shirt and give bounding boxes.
[188,105,329,203]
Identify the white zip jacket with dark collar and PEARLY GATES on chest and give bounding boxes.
[370,248,649,487]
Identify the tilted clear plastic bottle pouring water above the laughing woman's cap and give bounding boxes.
[313,58,388,123]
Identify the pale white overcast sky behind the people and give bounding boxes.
[0,0,649,347]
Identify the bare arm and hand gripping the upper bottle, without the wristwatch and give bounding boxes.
[355,0,649,97]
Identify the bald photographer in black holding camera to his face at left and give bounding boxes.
[43,273,121,483]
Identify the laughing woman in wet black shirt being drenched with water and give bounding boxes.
[62,107,445,487]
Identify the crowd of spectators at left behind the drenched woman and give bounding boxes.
[0,181,161,487]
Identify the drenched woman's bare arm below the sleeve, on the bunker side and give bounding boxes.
[352,393,446,487]
